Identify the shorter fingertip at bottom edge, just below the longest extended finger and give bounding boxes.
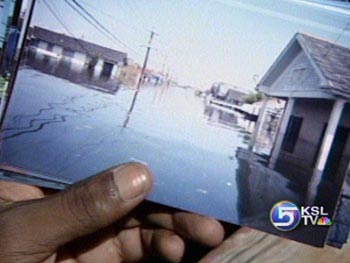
[141,229,185,262]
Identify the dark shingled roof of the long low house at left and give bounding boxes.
[31,26,127,64]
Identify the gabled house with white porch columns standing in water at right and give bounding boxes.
[254,33,350,248]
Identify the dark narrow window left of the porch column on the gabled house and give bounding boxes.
[282,116,303,153]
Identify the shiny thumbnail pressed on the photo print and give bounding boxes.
[113,164,150,201]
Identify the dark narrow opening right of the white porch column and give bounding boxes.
[323,126,350,181]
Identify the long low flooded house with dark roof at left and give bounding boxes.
[28,26,127,76]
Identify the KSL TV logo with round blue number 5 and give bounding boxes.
[270,201,332,231]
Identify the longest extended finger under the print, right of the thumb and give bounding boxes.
[135,205,225,246]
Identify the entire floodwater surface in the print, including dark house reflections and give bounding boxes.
[0,54,340,249]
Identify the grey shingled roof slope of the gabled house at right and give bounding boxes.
[296,33,350,98]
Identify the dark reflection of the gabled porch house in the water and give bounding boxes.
[236,145,349,249]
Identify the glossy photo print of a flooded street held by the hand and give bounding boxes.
[0,0,350,250]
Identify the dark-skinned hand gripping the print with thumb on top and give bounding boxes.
[0,163,224,263]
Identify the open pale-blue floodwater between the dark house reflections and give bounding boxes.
[2,60,254,224]
